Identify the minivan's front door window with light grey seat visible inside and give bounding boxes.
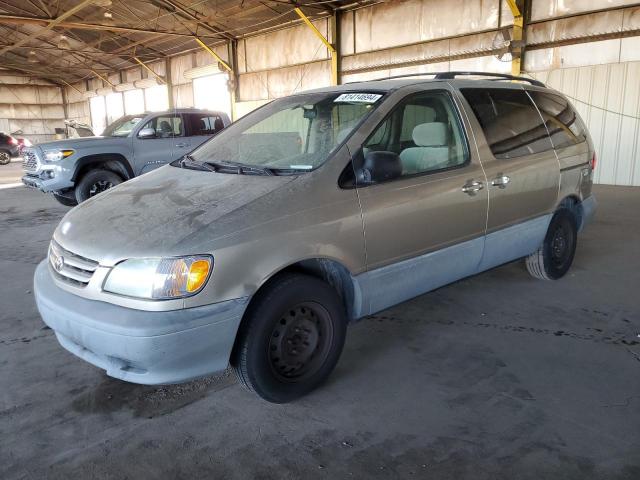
[363,92,469,176]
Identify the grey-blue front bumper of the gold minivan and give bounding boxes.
[34,260,248,385]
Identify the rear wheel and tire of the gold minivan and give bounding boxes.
[525,208,578,280]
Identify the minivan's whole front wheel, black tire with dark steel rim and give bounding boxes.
[231,274,347,403]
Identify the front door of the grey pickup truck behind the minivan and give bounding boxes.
[133,113,191,175]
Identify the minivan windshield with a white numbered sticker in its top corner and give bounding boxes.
[191,92,382,171]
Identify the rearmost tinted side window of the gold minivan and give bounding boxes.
[529,91,587,148]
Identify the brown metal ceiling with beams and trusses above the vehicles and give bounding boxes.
[0,0,376,83]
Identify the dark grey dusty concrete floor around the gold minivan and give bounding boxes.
[0,187,640,480]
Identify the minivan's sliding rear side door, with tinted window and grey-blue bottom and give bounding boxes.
[460,85,560,270]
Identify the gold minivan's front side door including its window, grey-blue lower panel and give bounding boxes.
[354,83,487,313]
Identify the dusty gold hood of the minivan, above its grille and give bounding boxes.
[54,165,296,265]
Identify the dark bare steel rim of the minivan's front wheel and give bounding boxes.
[269,302,333,382]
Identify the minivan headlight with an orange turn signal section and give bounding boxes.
[103,255,213,300]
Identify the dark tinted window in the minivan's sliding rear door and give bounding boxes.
[461,88,553,159]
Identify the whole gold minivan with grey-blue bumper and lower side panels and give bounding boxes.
[35,72,596,402]
